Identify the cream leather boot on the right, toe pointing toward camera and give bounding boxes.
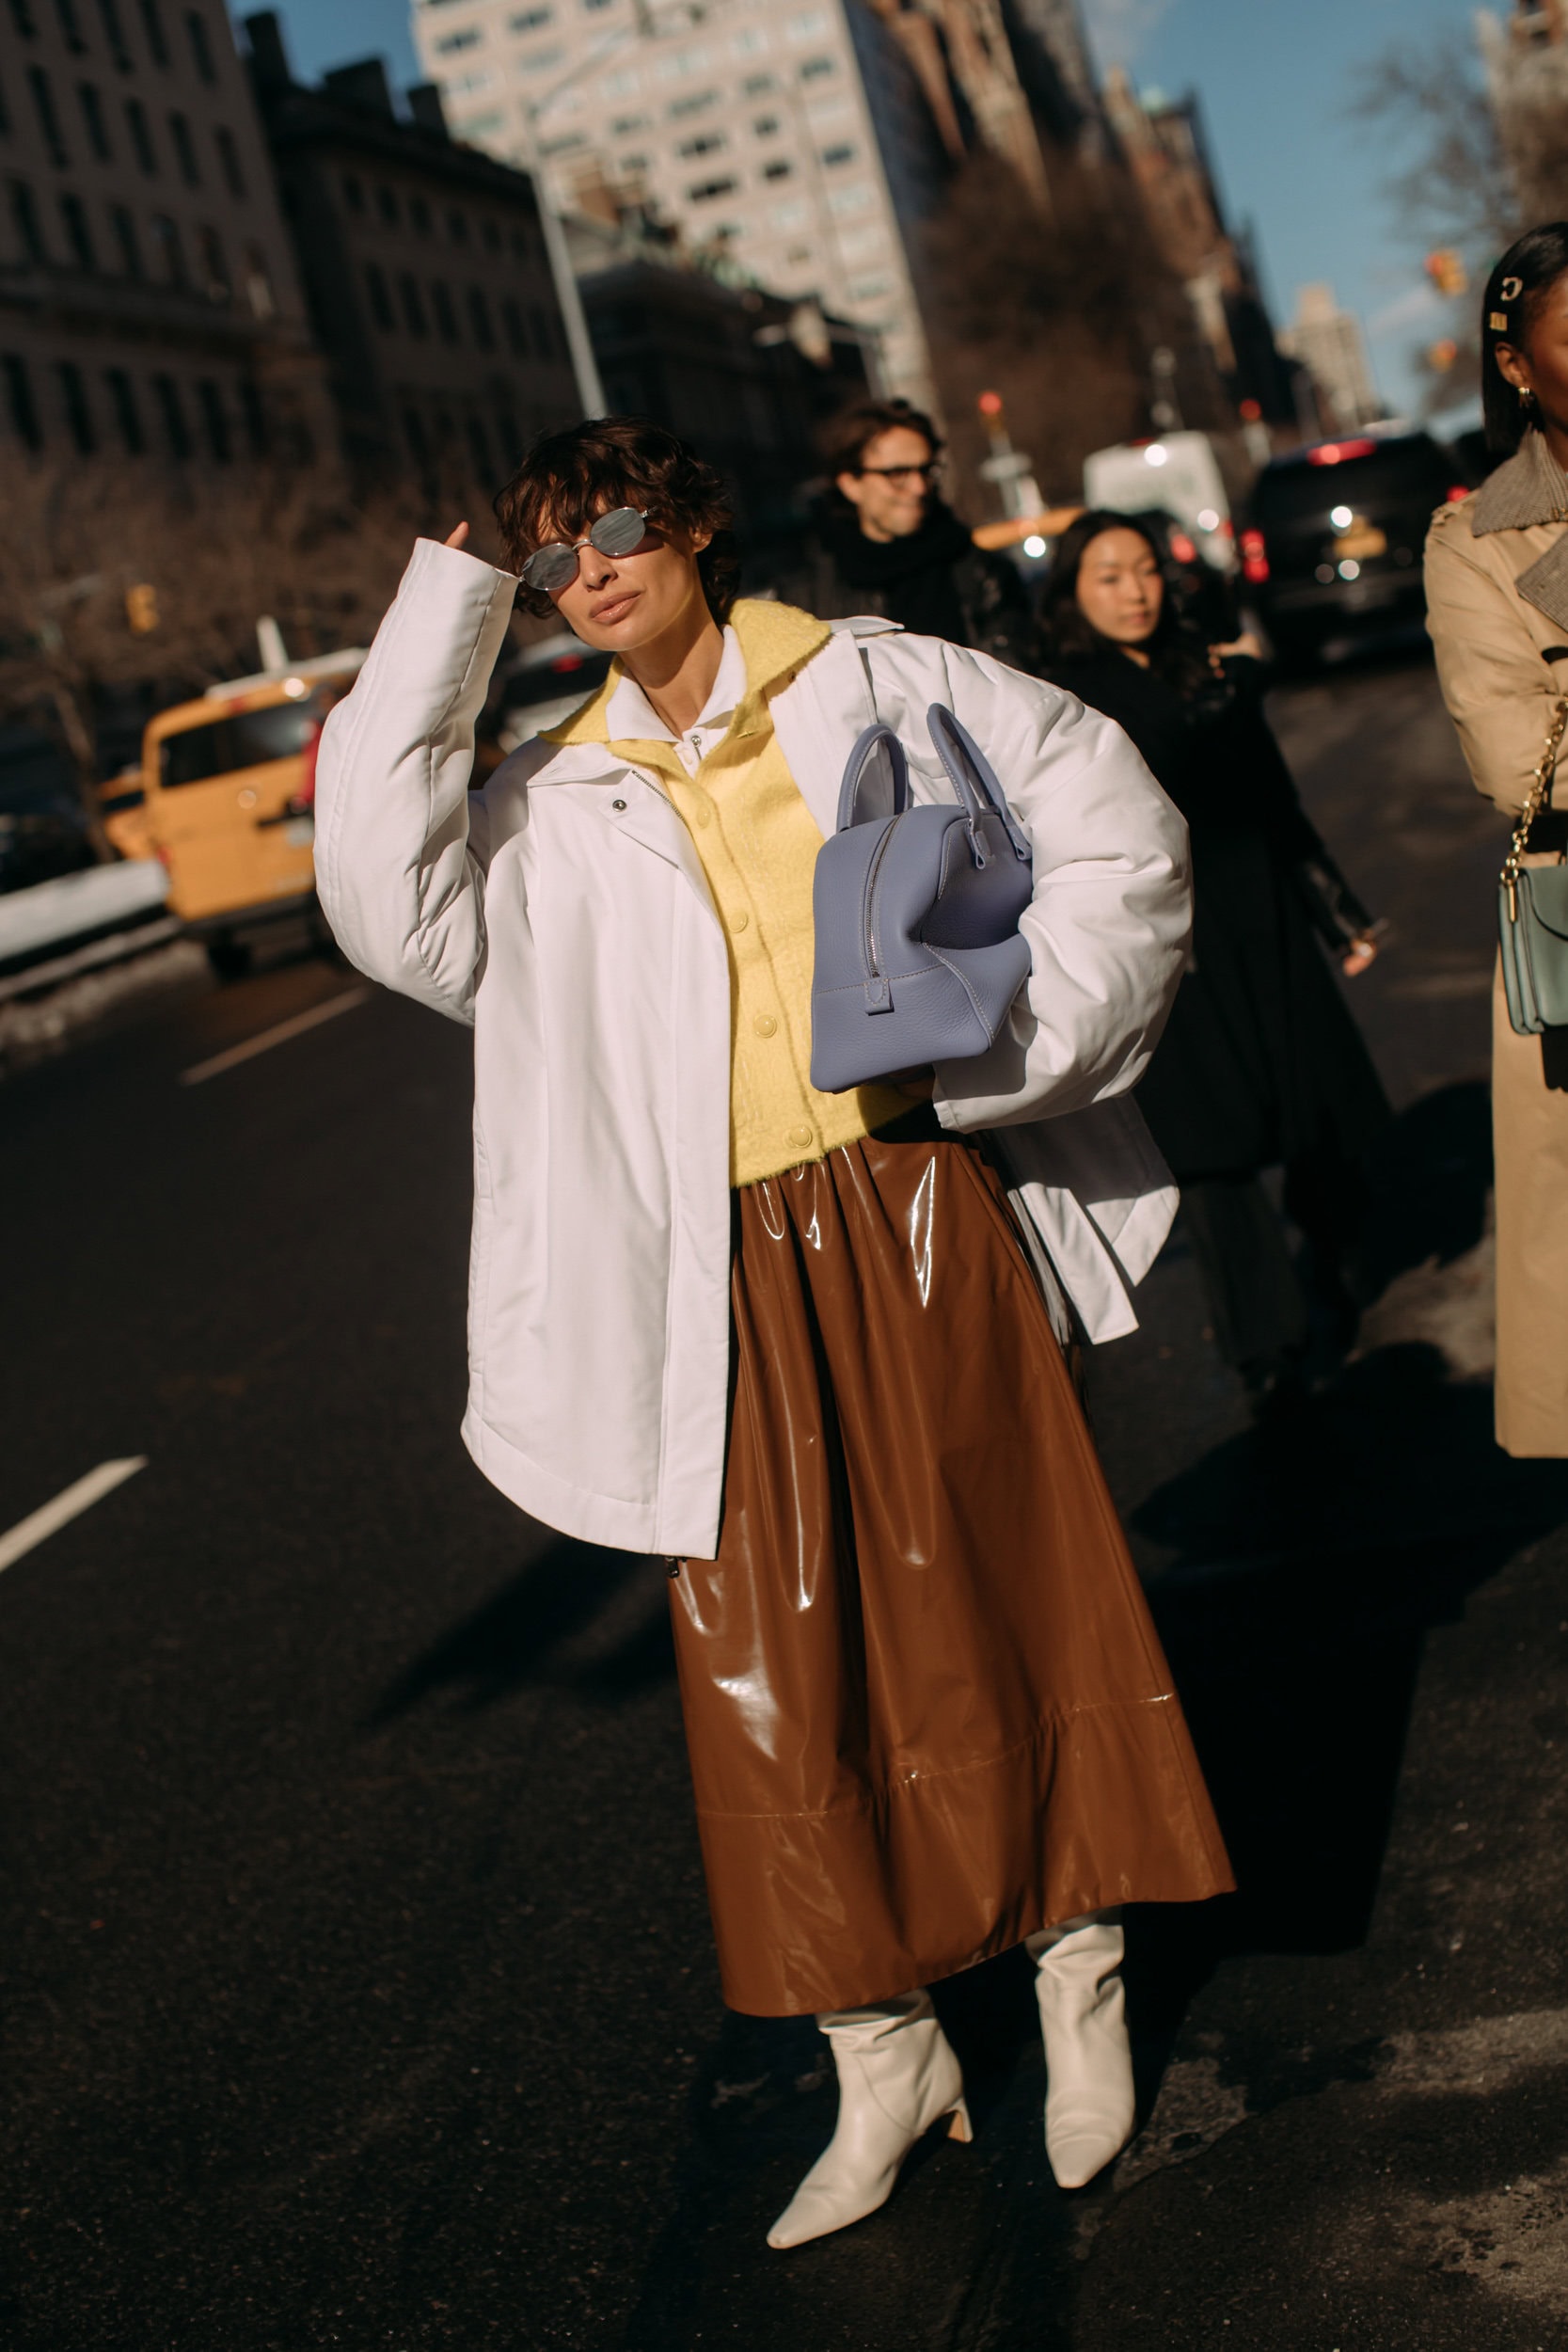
[1027,1910,1133,2190]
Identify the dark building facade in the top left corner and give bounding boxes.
[0,0,329,466]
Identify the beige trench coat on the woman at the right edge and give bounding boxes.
[1427,499,1568,1456]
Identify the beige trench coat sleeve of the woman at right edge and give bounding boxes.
[1427,506,1563,817]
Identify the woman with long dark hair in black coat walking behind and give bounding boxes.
[1041,511,1387,1406]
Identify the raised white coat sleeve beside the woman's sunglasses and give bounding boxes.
[315,539,517,1021]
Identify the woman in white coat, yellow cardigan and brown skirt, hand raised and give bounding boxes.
[317,417,1227,2247]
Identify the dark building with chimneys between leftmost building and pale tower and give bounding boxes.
[245,9,580,489]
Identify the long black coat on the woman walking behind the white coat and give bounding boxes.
[1051,654,1389,1184]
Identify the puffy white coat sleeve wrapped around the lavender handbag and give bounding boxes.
[907,644,1192,1132]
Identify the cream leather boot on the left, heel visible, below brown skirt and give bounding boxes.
[768,1993,971,2247]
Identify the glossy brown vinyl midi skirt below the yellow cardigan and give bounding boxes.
[670,1122,1232,2016]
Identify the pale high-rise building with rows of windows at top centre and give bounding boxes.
[414,0,945,400]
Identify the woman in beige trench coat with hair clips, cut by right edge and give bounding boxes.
[1427,221,1568,1456]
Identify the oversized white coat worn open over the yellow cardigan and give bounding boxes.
[315,539,1190,1557]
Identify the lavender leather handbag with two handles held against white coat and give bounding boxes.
[811,704,1035,1094]
